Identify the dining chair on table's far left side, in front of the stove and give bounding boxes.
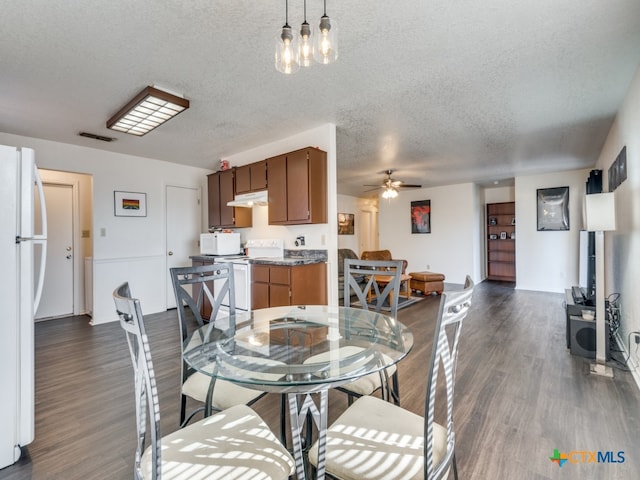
[170,263,266,426]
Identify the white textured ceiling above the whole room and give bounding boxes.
[0,0,640,195]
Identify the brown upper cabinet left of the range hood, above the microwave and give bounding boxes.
[207,168,253,227]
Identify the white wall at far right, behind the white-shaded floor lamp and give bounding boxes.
[596,64,640,378]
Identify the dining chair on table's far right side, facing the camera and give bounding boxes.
[338,258,403,405]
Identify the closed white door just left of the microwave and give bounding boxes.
[166,185,202,309]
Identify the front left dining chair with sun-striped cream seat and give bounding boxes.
[113,283,294,480]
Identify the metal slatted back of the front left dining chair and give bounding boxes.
[113,283,162,480]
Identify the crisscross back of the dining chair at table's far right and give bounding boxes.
[344,258,402,318]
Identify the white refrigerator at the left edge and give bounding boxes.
[0,145,47,468]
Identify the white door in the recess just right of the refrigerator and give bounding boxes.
[35,183,74,320]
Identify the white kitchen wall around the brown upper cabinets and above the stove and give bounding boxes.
[224,123,338,305]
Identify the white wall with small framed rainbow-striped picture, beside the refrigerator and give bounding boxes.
[0,133,210,324]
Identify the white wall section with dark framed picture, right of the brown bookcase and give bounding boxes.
[515,170,589,293]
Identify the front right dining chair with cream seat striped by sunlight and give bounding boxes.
[309,276,474,480]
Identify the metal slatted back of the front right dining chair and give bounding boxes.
[424,276,474,480]
